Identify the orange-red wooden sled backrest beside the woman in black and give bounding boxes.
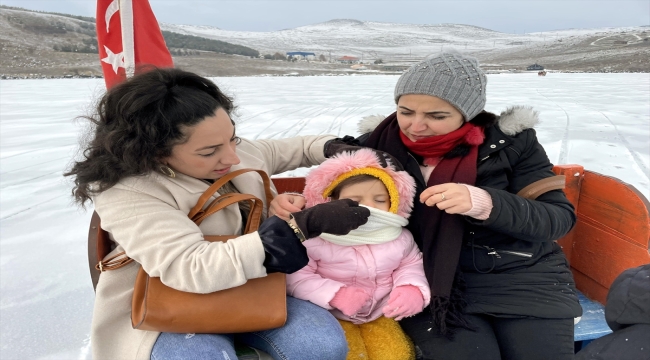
[553,165,650,304]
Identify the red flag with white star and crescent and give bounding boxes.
[97,0,174,88]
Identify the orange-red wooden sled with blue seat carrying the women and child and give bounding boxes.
[88,165,650,341]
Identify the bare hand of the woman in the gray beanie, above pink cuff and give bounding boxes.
[420,183,472,214]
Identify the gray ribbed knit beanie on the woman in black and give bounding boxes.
[395,52,487,121]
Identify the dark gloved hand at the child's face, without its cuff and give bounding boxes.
[291,199,370,239]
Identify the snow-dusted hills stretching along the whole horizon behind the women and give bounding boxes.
[0,6,650,78]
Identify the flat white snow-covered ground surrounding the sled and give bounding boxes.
[0,73,650,359]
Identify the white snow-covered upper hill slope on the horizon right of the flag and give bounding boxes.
[161,19,647,60]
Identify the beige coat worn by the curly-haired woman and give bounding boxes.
[91,136,332,360]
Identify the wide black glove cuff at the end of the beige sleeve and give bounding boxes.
[257,216,309,274]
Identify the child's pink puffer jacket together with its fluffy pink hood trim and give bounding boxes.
[287,149,431,324]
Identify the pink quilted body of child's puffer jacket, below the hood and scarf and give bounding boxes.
[287,229,431,324]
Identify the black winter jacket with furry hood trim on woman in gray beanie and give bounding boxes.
[358,107,582,318]
